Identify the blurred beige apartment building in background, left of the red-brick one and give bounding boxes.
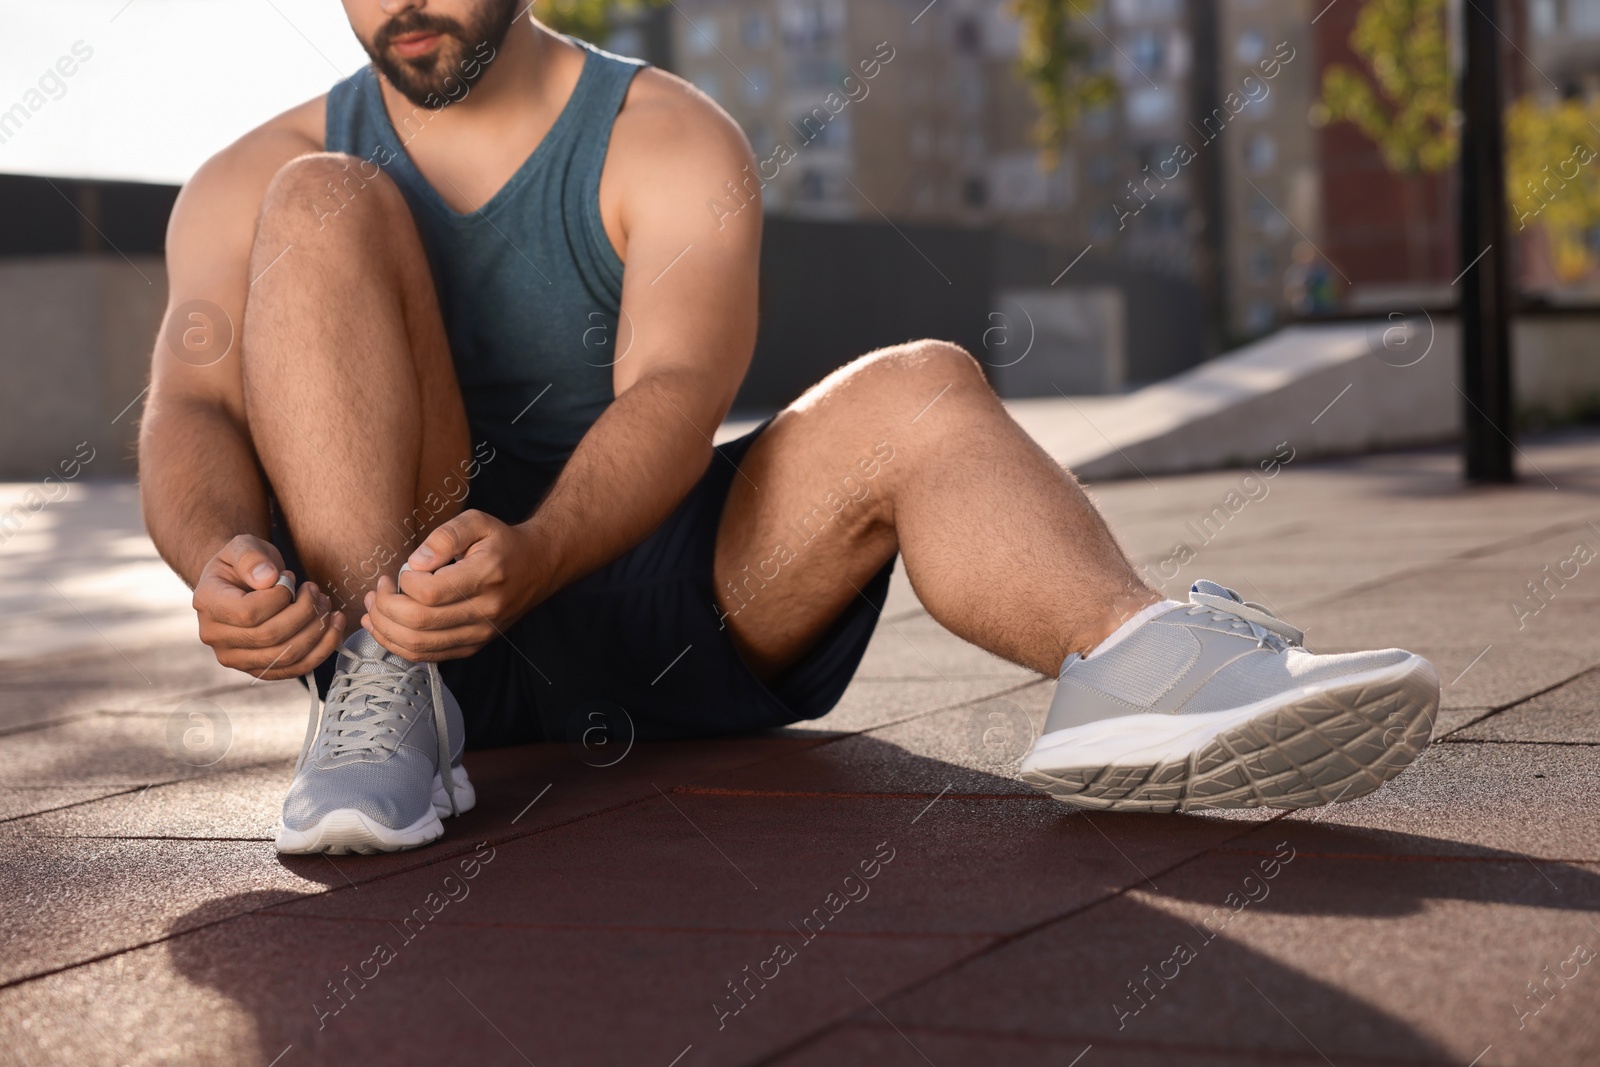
[656,0,1331,343]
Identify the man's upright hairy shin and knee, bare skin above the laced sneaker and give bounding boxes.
[242,154,469,619]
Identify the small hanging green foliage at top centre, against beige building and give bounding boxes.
[1011,0,1117,162]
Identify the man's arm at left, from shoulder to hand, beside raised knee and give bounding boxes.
[139,108,342,678]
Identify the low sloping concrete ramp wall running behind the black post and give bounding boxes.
[1011,312,1600,480]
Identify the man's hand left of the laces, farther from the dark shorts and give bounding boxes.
[194,534,344,681]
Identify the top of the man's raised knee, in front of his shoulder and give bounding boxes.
[259,152,408,238]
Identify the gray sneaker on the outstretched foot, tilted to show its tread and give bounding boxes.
[1022,581,1438,811]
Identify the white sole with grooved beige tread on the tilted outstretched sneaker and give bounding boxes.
[1022,656,1438,811]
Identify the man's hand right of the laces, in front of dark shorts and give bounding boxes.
[362,510,542,661]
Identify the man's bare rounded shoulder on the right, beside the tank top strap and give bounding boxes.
[610,67,754,206]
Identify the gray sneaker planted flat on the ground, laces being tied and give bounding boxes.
[277,630,477,853]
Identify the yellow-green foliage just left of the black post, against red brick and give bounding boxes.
[1320,0,1459,176]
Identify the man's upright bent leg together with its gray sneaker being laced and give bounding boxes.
[242,155,474,853]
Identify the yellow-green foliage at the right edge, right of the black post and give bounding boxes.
[1506,98,1600,282]
